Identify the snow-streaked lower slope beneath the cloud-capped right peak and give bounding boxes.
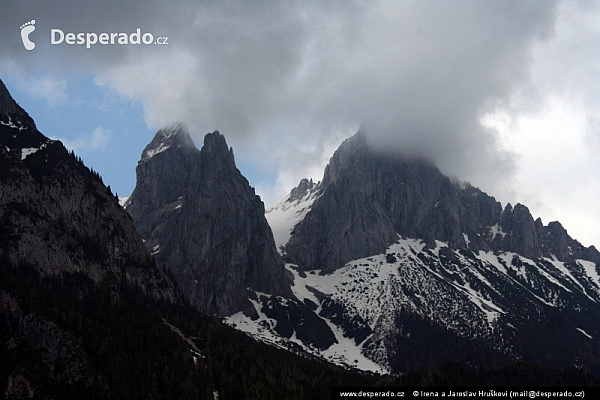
[226,233,600,372]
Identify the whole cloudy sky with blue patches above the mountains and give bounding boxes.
[0,0,600,247]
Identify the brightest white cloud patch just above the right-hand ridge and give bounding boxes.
[482,97,600,246]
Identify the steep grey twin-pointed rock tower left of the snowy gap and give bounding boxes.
[125,124,291,316]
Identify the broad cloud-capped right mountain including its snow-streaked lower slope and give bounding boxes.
[231,131,600,372]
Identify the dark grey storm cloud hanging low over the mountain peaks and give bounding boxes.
[0,1,554,188]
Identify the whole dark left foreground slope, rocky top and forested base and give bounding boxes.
[0,77,374,399]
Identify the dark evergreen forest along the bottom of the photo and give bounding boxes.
[0,263,600,399]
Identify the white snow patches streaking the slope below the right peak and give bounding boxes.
[226,233,600,372]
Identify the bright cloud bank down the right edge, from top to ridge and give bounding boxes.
[477,1,600,247]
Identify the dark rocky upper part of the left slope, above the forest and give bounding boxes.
[0,78,175,300]
